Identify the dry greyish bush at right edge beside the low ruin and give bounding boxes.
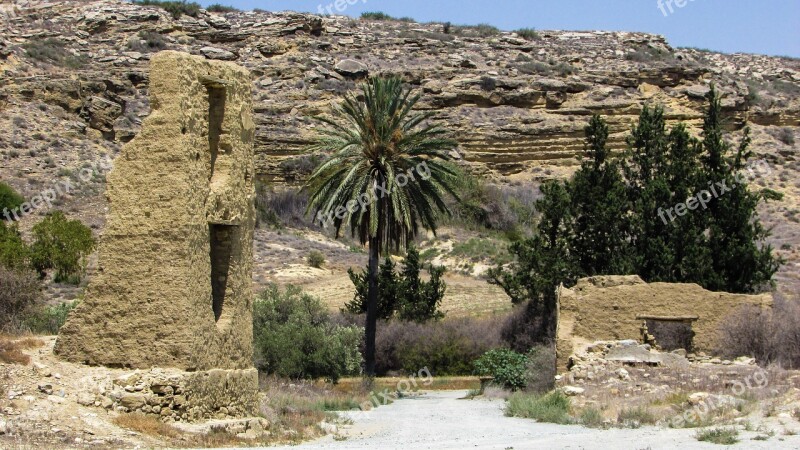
[717,294,800,369]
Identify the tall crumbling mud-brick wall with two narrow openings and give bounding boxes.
[55,51,257,372]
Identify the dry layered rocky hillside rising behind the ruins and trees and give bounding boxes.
[0,0,800,295]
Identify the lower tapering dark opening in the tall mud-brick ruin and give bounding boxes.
[209,223,239,322]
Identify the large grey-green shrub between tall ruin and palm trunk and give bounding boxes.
[253,284,363,382]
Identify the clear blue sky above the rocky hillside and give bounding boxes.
[199,0,800,57]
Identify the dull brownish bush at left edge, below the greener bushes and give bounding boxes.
[0,265,42,332]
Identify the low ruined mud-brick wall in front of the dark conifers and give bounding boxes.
[556,275,772,372]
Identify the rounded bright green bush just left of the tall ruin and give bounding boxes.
[31,211,96,284]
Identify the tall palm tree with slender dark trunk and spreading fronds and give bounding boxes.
[305,77,458,377]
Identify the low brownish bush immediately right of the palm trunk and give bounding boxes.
[375,317,503,376]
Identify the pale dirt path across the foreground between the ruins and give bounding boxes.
[264,391,800,450]
